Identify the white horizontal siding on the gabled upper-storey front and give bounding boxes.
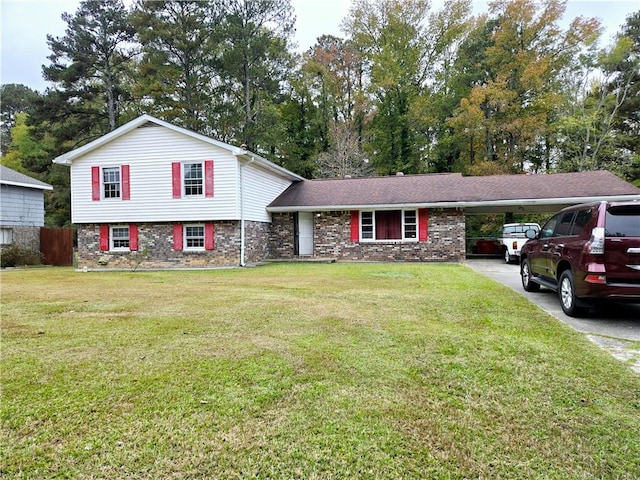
[71,126,239,223]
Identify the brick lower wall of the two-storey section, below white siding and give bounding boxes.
[78,221,269,269]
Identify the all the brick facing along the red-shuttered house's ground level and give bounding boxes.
[78,209,465,269]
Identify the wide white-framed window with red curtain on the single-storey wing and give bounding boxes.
[360,210,418,241]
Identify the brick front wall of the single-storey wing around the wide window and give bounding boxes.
[270,209,465,262]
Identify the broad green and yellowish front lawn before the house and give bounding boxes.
[0,264,640,479]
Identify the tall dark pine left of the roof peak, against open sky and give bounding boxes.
[39,0,136,137]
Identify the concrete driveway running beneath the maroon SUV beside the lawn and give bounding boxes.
[466,259,640,373]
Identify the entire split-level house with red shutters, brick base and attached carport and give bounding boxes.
[54,115,640,268]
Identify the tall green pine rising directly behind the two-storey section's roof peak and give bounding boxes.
[132,0,221,135]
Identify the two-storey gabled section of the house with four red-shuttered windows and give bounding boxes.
[54,115,303,268]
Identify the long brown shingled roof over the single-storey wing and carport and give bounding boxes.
[268,171,640,211]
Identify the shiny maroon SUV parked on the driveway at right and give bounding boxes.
[520,202,640,317]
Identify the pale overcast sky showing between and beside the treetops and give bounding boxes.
[0,0,640,92]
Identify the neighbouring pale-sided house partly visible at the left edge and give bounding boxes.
[0,165,53,252]
